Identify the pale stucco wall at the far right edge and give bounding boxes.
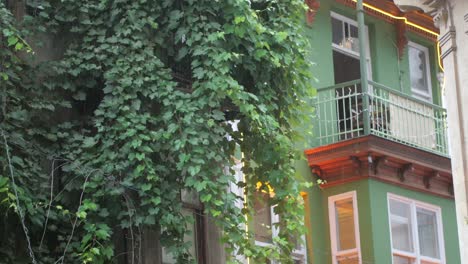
[440,0,468,263]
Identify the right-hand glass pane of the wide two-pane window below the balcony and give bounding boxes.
[416,208,440,259]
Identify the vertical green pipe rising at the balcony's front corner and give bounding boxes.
[356,0,370,135]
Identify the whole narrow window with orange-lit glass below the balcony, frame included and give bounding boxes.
[328,191,362,264]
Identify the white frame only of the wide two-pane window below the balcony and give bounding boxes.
[387,193,446,264]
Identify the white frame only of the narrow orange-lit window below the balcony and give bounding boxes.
[328,191,362,264]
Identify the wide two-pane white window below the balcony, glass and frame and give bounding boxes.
[388,194,445,264]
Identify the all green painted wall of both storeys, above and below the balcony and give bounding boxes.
[296,0,454,264]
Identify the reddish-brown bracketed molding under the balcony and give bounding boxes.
[305,135,454,199]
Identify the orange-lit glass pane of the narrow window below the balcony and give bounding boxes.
[335,198,356,251]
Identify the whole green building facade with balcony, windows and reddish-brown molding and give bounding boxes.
[297,0,460,264]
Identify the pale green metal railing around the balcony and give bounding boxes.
[313,80,448,156]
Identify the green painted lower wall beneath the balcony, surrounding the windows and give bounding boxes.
[308,179,460,264]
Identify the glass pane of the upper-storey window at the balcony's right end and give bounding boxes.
[408,46,429,94]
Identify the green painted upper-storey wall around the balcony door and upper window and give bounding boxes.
[306,1,441,146]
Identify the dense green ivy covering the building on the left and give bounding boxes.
[0,0,310,263]
